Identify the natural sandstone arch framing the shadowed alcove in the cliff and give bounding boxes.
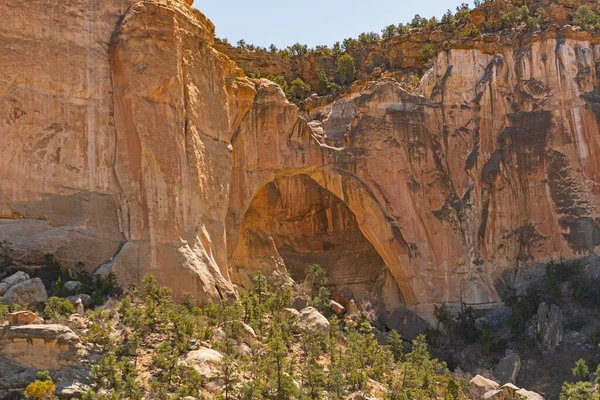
[227,80,422,312]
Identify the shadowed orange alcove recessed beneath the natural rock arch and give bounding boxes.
[232,174,403,311]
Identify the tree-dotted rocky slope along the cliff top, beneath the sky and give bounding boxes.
[217,0,600,102]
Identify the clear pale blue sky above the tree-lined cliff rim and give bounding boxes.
[202,0,470,47]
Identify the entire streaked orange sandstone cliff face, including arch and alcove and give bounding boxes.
[0,0,600,318]
